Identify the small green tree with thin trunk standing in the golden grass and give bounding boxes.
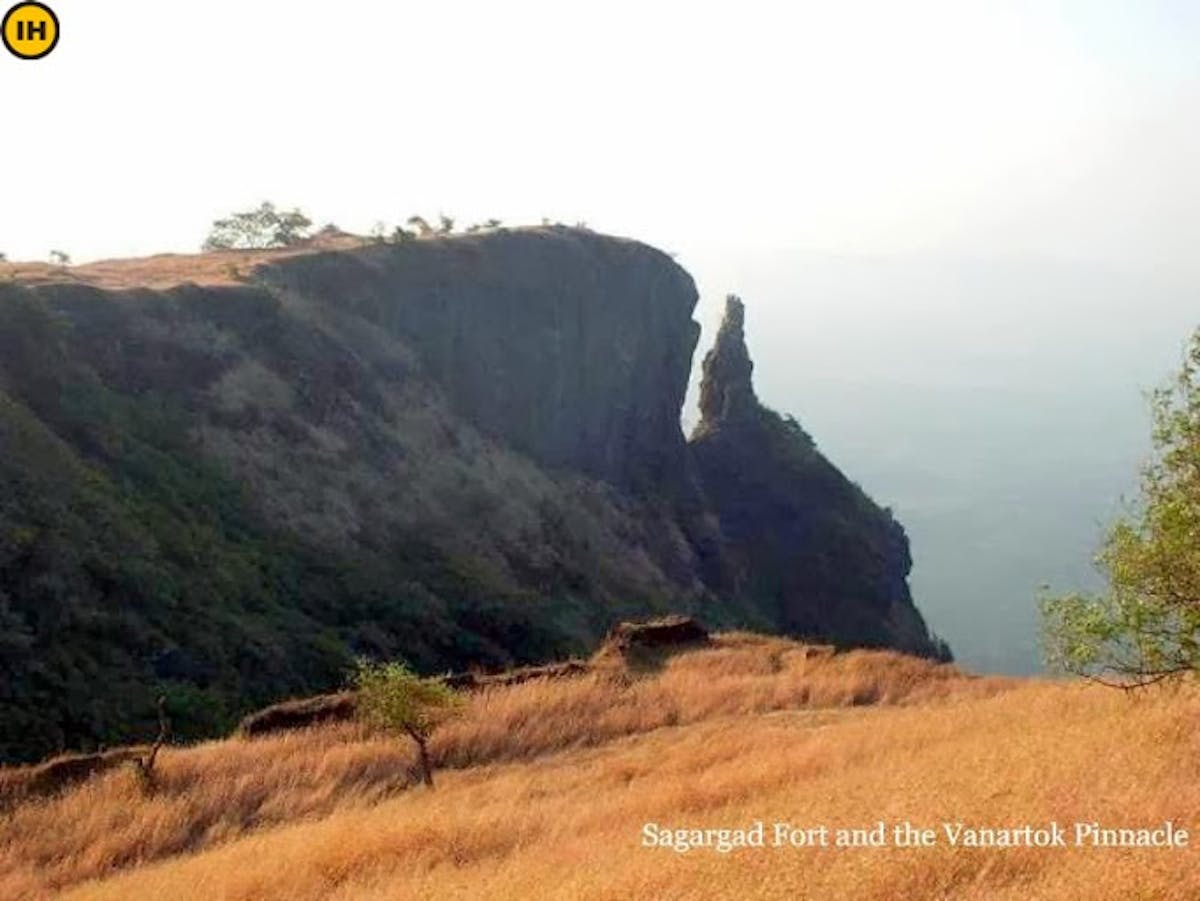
[354,660,461,788]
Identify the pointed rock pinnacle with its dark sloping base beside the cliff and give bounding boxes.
[691,296,948,656]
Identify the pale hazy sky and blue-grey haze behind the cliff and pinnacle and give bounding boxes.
[0,0,1200,672]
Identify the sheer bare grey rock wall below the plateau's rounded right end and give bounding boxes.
[263,228,700,489]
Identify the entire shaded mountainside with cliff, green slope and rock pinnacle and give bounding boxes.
[0,228,932,759]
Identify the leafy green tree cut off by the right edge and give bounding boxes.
[1042,329,1200,686]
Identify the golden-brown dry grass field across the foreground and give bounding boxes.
[0,633,1200,901]
